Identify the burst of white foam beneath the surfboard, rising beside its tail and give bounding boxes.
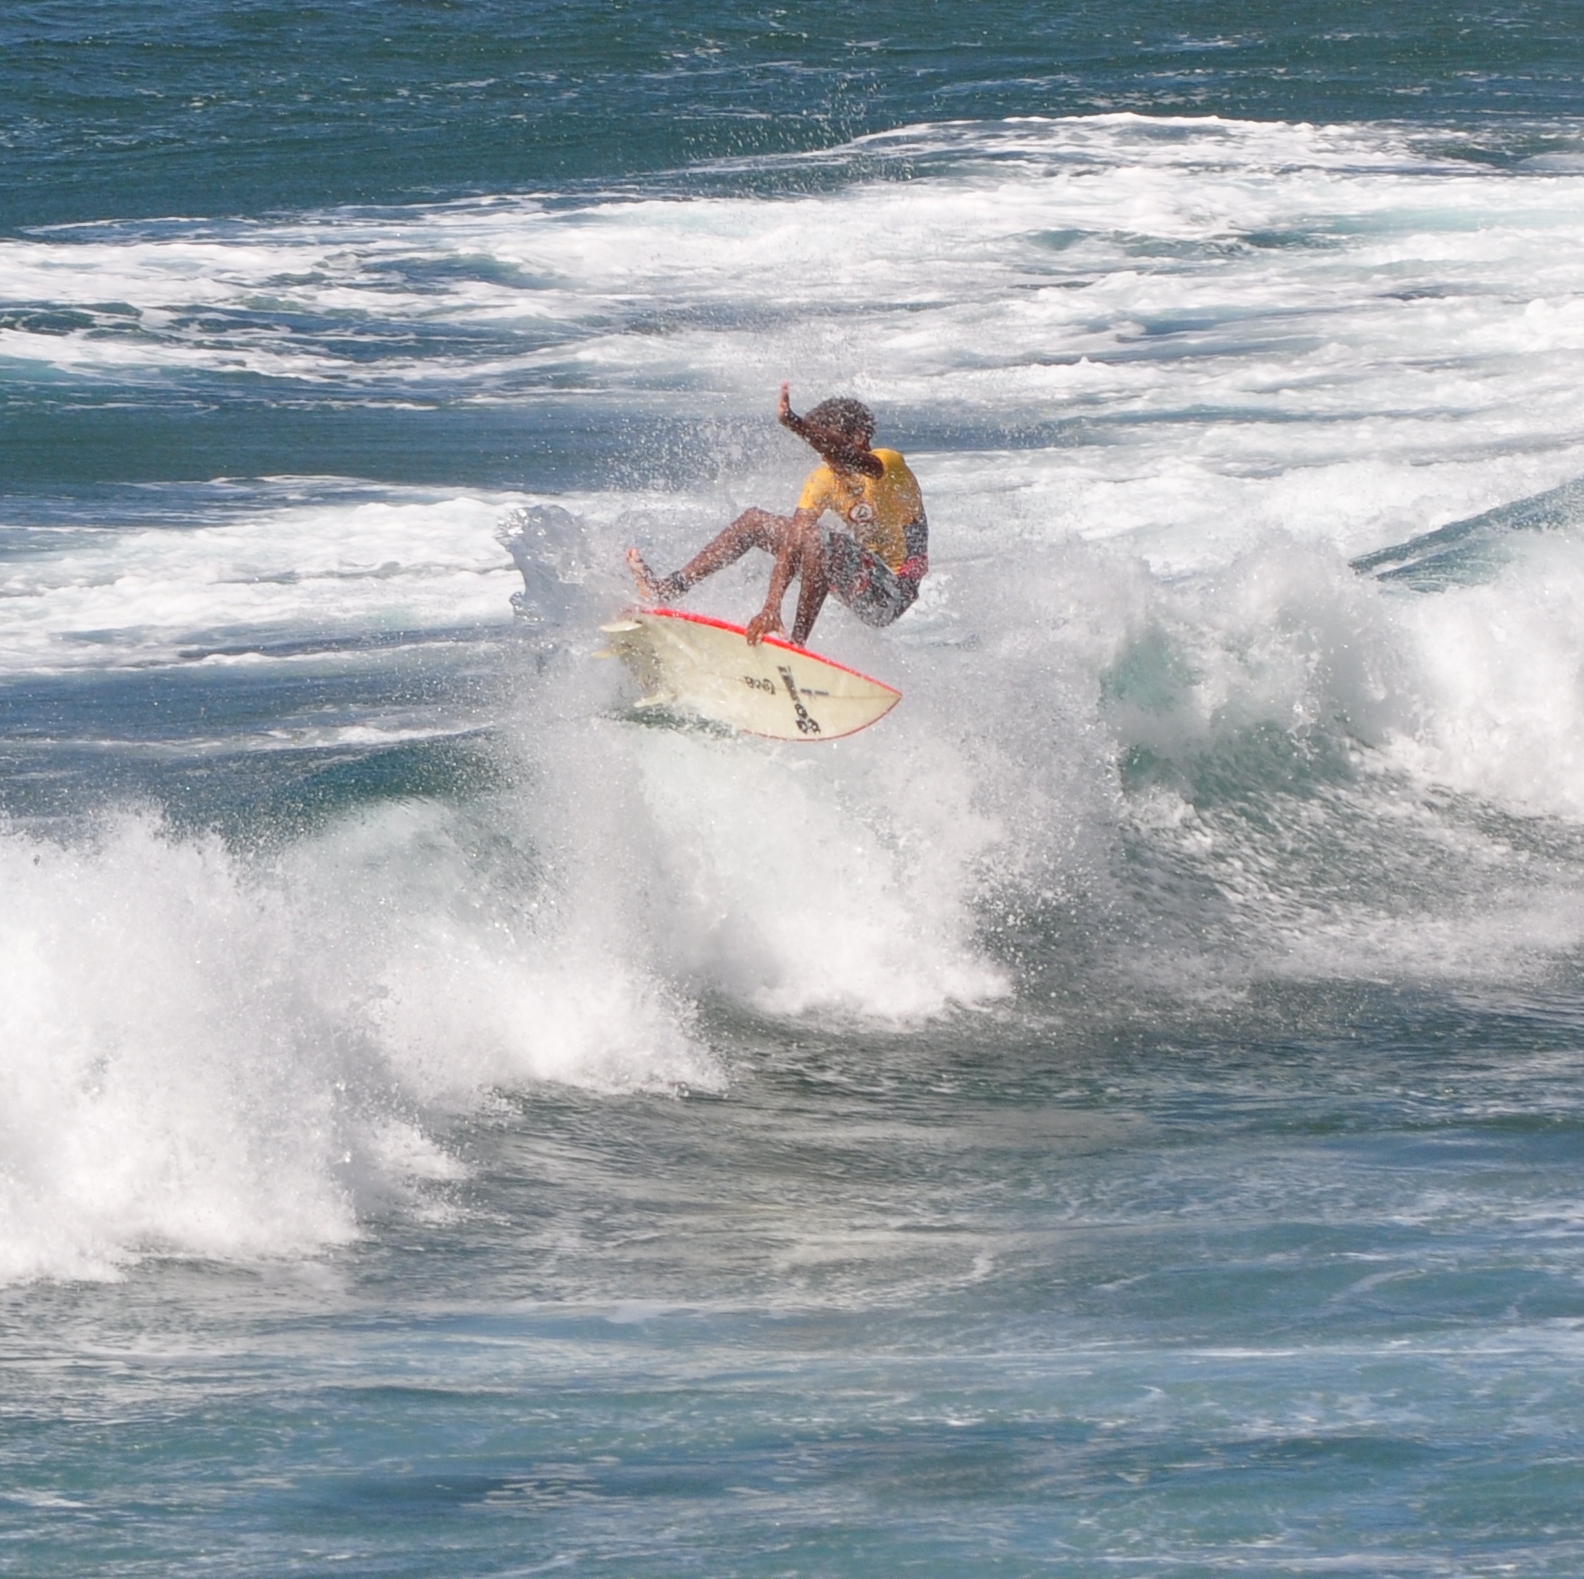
[484,627,1007,1023]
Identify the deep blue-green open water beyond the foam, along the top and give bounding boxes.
[0,0,1578,231]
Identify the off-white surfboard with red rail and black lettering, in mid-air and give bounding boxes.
[600,608,901,740]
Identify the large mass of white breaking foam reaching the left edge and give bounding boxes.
[0,808,718,1280]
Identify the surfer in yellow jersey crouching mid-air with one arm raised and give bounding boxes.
[627,383,930,646]
